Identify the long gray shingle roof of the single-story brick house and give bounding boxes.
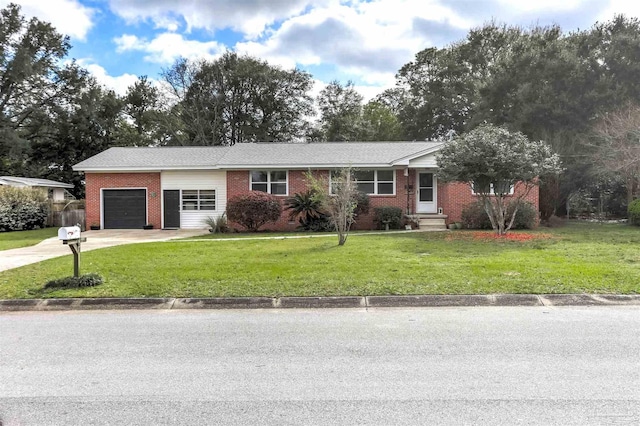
[73,142,443,171]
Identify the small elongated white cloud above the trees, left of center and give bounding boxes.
[113,33,225,65]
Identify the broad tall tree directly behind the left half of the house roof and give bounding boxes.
[163,52,311,145]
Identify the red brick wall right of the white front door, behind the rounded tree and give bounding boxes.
[438,182,539,223]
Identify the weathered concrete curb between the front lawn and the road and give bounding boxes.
[0,294,640,312]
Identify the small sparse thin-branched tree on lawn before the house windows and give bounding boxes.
[306,167,368,246]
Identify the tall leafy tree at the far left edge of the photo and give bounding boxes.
[0,4,77,174]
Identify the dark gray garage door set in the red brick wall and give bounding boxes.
[102,189,147,229]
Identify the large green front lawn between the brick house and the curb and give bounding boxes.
[0,223,640,298]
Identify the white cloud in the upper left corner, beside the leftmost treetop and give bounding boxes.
[0,0,95,40]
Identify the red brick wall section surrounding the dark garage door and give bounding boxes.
[85,173,162,228]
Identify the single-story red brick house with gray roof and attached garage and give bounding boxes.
[74,142,538,230]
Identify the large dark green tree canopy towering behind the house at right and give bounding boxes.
[390,16,640,216]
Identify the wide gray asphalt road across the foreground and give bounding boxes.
[0,307,640,426]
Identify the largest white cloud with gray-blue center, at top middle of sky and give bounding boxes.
[235,0,473,86]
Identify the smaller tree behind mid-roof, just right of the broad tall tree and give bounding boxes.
[317,80,363,142]
